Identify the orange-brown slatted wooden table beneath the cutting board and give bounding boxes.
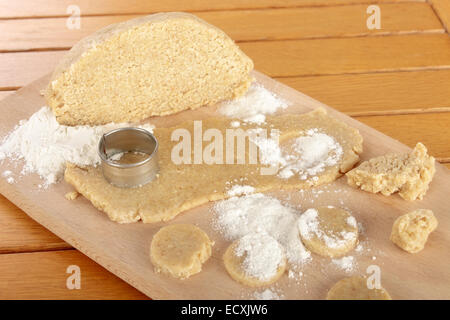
[0,0,450,299]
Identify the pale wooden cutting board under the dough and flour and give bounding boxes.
[0,72,450,299]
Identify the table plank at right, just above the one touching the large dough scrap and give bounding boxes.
[278,70,450,116]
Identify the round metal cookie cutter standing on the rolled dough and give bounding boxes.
[98,127,159,188]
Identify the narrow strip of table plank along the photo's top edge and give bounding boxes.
[0,0,426,18]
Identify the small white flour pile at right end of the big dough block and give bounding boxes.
[218,83,288,124]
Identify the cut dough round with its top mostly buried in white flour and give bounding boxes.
[223,233,286,287]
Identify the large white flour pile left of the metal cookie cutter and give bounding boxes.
[0,107,153,187]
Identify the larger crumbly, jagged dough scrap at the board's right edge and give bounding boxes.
[346,142,436,201]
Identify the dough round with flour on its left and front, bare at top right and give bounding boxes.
[298,206,358,258]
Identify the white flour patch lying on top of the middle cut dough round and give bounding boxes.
[235,233,284,281]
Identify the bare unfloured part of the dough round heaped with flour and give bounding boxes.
[223,234,287,287]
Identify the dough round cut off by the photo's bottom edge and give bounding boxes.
[327,276,392,300]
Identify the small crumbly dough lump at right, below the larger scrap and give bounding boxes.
[391,209,438,253]
